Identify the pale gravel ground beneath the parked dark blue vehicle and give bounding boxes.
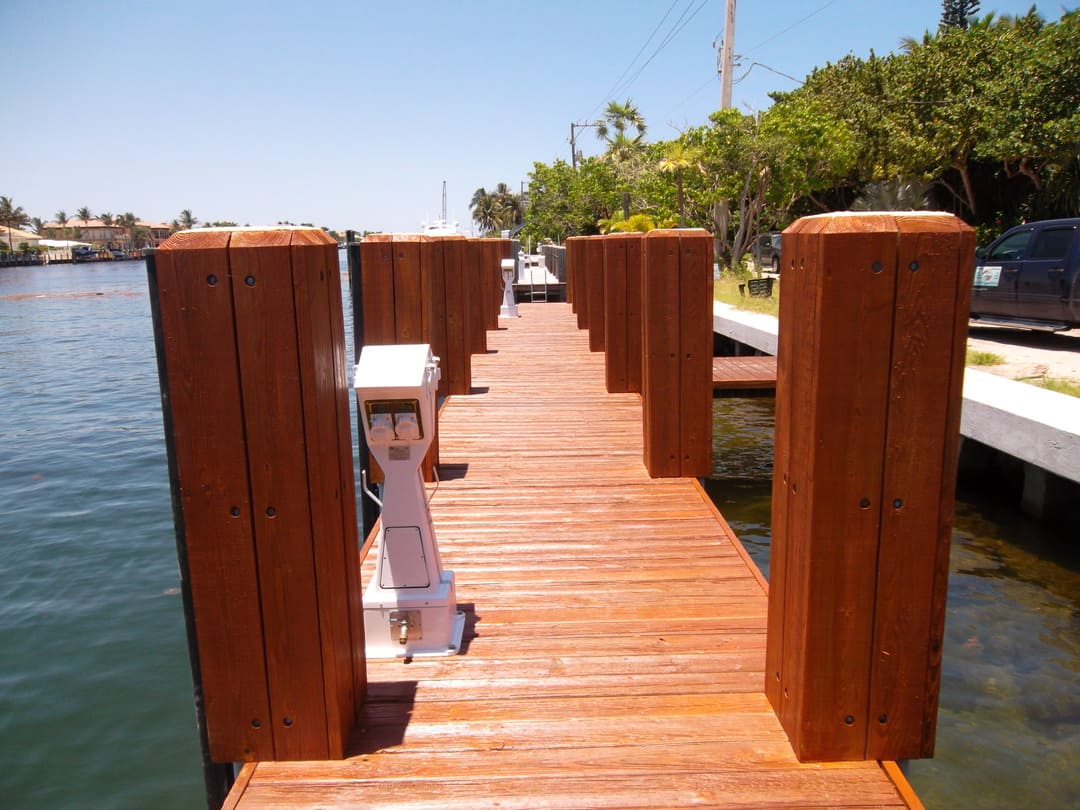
[968,323,1080,382]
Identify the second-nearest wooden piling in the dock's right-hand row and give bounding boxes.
[639,229,713,477]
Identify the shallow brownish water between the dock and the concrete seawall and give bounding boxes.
[707,397,1080,810]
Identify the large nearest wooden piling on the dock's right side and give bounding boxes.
[766,214,974,760]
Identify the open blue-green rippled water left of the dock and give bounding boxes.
[0,261,202,808]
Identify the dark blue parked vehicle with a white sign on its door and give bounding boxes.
[971,218,1080,332]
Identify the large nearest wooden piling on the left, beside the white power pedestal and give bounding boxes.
[151,229,365,762]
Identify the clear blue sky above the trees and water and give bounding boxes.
[0,0,1074,232]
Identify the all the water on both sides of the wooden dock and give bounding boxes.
[0,262,1080,809]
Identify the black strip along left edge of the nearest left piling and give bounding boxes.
[144,249,235,810]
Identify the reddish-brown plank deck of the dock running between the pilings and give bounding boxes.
[226,303,920,810]
